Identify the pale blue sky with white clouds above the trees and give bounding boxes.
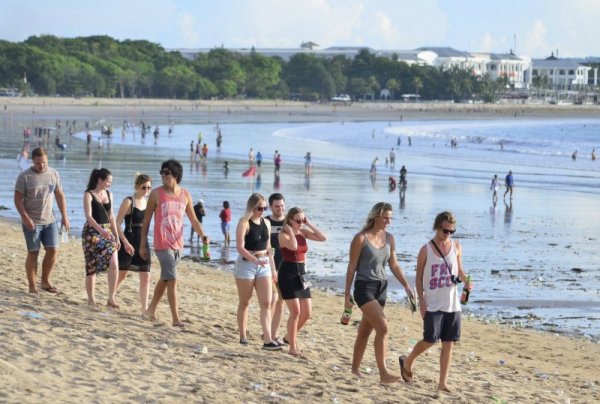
[0,0,600,57]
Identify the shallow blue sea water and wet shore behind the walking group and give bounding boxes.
[0,119,600,340]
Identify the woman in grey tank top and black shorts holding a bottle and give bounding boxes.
[344,202,412,383]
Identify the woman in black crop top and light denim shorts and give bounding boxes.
[234,193,282,351]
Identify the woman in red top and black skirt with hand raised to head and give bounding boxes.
[278,208,327,356]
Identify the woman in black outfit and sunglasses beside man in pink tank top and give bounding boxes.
[117,174,152,314]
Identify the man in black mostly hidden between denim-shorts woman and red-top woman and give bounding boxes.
[266,192,285,345]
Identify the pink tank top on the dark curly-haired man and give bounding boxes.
[154,187,187,250]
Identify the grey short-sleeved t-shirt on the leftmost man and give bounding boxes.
[15,167,62,225]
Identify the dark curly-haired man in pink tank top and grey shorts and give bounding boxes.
[140,160,205,328]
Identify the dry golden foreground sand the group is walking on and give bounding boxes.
[0,220,600,403]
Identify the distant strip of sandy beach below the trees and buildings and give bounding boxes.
[0,97,600,124]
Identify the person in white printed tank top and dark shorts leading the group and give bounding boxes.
[400,212,472,392]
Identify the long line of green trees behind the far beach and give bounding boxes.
[0,35,506,102]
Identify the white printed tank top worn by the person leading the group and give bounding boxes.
[423,241,461,313]
